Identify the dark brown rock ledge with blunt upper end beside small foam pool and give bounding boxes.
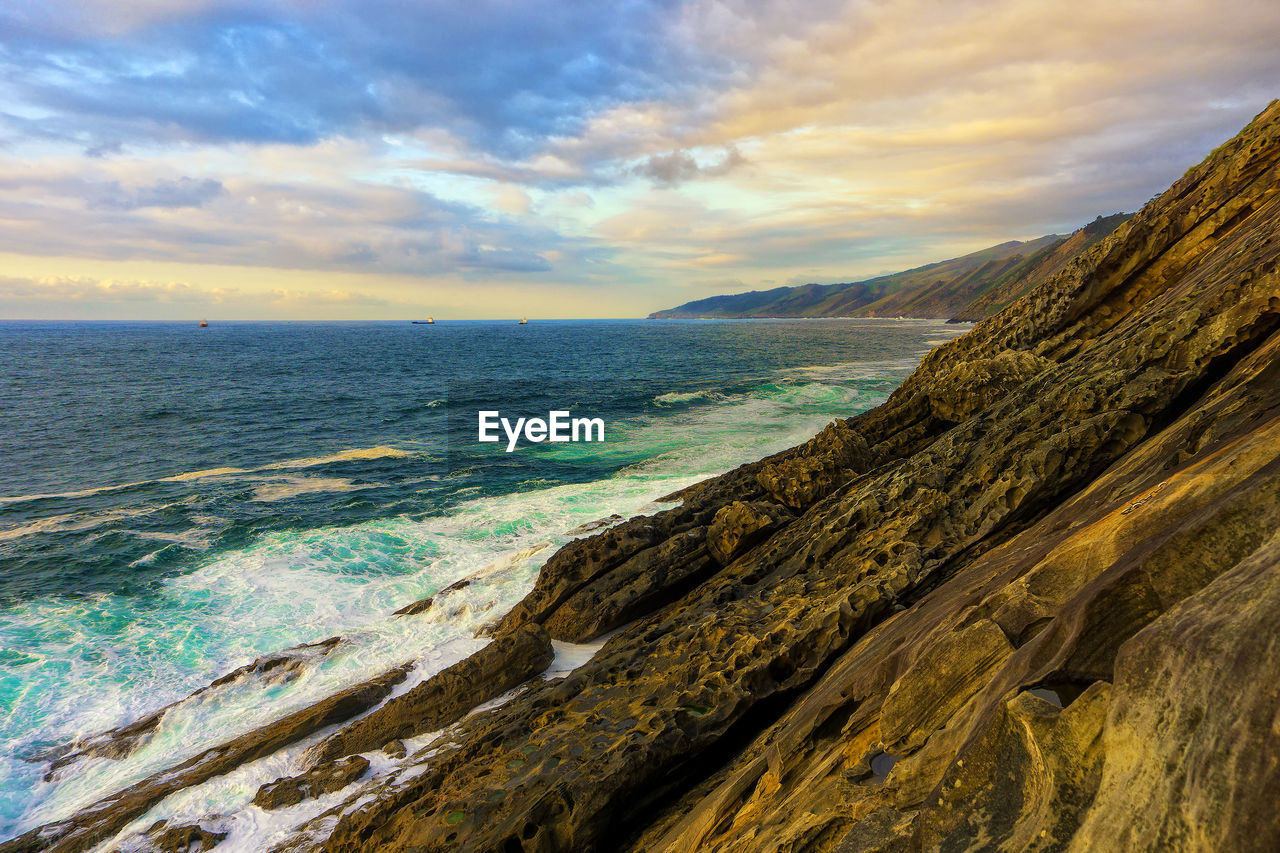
[305,624,556,768]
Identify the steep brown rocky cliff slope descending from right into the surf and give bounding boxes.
[10,102,1280,852]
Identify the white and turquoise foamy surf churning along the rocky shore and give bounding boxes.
[0,362,931,849]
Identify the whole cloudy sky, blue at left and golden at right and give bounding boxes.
[0,0,1280,320]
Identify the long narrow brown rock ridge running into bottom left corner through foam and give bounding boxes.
[0,665,410,853]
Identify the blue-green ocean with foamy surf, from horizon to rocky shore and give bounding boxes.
[0,320,964,850]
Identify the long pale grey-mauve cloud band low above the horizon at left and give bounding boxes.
[0,160,586,280]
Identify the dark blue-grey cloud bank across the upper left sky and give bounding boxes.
[0,0,724,155]
